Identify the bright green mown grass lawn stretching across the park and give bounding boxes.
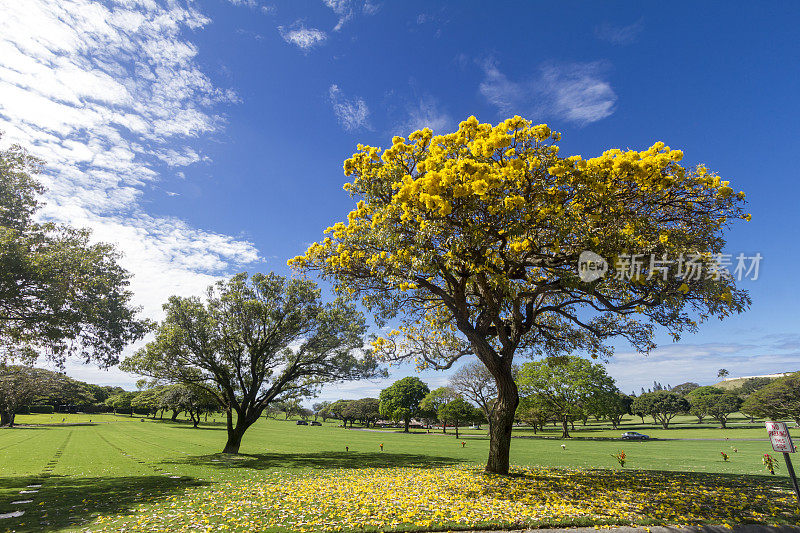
[0,415,800,531]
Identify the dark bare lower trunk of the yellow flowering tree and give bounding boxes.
[486,363,519,474]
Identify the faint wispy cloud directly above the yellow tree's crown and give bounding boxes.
[479,60,617,125]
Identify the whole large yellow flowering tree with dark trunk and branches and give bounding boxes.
[289,117,749,473]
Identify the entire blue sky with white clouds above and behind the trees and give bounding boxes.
[0,0,800,399]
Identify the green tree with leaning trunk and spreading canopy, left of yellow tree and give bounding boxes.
[121,273,381,453]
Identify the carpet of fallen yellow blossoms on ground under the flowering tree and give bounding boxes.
[100,467,800,532]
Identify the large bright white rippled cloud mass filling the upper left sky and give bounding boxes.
[0,0,260,358]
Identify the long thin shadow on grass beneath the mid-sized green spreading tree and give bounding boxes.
[167,452,464,470]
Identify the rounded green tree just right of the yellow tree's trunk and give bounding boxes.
[517,356,617,438]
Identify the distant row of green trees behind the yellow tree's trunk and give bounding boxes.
[296,362,800,437]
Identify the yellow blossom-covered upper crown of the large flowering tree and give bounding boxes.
[289,116,750,296]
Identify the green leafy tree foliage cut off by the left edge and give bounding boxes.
[0,139,150,368]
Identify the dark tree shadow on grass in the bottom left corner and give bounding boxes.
[0,475,209,531]
